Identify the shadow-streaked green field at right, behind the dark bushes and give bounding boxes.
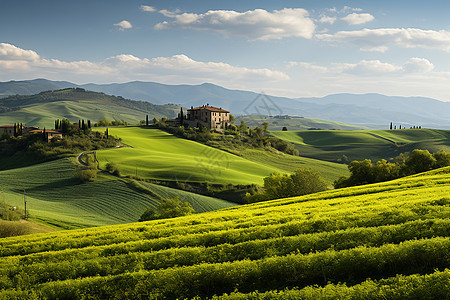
[271,129,450,161]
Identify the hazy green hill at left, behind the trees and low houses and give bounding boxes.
[0,88,180,128]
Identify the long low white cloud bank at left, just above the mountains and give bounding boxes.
[0,44,289,88]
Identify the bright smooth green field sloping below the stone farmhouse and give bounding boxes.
[97,127,347,184]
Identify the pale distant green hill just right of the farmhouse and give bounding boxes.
[234,115,367,131]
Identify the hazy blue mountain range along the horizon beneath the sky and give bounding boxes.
[0,79,450,129]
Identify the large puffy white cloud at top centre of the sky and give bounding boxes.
[155,8,315,40]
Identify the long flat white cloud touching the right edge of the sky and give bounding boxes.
[316,28,450,51]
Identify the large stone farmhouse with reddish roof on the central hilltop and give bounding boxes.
[179,104,230,131]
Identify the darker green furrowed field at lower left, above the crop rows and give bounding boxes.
[0,158,233,229]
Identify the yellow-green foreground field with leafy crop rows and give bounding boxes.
[0,168,450,299]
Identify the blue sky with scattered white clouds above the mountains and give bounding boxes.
[0,0,450,101]
